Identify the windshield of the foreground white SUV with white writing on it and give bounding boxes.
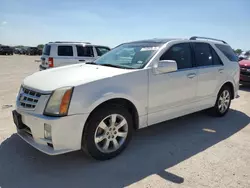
[95,43,161,69]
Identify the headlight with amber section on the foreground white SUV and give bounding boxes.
[44,87,73,116]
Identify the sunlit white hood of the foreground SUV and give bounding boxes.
[23,64,134,92]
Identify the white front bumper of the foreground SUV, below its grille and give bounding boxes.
[14,110,87,155]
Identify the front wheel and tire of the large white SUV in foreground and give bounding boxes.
[82,104,133,161]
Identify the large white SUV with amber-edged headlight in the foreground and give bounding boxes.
[13,37,239,160]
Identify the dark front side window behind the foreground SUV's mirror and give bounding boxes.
[160,43,192,69]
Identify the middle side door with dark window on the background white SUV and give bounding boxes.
[76,45,95,63]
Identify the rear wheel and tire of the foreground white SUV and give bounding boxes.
[210,86,232,117]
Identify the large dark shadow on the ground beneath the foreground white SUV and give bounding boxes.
[0,110,250,188]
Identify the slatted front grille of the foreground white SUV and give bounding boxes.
[18,87,41,109]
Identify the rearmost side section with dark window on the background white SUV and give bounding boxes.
[54,44,77,67]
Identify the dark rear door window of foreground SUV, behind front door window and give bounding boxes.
[193,43,213,66]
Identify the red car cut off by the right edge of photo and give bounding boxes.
[239,58,250,84]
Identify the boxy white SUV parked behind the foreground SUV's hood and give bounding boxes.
[39,42,110,70]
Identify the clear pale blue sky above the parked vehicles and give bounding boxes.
[0,0,250,50]
